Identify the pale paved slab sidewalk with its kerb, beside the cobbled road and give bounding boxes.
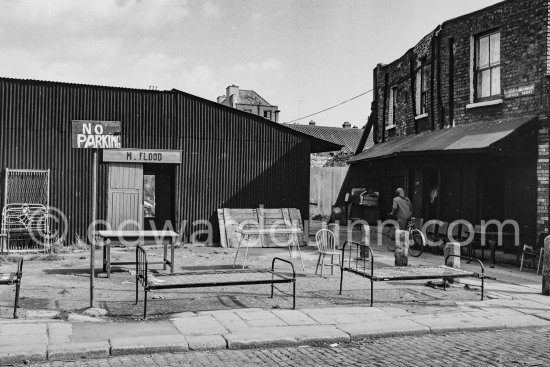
[0,294,550,364]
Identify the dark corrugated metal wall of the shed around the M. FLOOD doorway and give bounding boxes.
[0,78,311,242]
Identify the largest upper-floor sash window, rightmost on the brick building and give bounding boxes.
[475,30,500,101]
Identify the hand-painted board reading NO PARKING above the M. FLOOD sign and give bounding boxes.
[72,120,121,149]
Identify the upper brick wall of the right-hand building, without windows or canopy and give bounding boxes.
[373,0,550,239]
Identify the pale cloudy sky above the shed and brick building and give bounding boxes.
[0,0,499,127]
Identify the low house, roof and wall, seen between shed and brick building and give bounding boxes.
[286,120,373,167]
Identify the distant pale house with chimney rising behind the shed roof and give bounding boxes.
[218,85,279,122]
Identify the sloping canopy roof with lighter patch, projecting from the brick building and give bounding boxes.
[348,115,537,163]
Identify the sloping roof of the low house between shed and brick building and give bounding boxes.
[284,124,365,153]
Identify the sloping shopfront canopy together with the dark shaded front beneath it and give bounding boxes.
[338,115,538,246]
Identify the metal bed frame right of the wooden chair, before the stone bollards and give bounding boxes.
[339,241,487,307]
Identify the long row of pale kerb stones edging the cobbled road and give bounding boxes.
[0,316,550,364]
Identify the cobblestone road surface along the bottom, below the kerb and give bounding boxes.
[33,328,550,367]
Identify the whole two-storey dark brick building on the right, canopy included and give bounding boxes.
[339,0,550,246]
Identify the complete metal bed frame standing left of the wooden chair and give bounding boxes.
[135,245,296,319]
